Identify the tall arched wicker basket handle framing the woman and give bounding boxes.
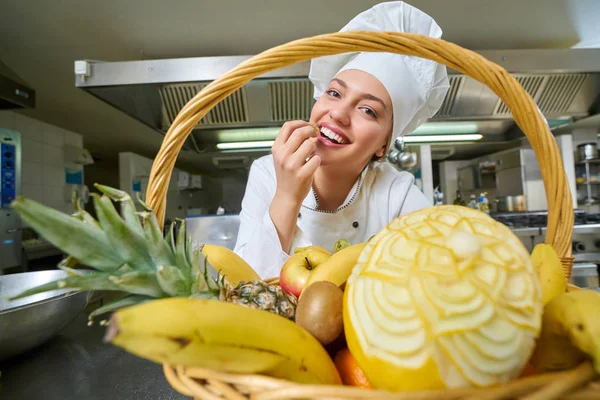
[146,31,574,278]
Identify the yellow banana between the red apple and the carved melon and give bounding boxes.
[304,242,367,288]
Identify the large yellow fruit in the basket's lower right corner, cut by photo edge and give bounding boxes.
[530,289,600,373]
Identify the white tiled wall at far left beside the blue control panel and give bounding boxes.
[0,110,83,219]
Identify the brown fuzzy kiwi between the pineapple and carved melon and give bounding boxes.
[296,281,344,345]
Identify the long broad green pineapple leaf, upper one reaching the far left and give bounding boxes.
[11,196,123,271]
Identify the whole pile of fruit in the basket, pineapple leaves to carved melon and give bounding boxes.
[12,185,600,391]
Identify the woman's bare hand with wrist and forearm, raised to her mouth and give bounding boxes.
[269,121,321,254]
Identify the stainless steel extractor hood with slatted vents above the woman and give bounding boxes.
[75,49,600,153]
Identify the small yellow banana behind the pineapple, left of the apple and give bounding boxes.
[201,243,260,286]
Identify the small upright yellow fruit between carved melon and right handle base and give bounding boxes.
[531,243,567,304]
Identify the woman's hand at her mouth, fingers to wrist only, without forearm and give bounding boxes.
[271,121,321,205]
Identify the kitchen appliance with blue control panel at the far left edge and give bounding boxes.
[0,128,23,273]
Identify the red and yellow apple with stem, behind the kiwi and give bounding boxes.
[279,248,331,297]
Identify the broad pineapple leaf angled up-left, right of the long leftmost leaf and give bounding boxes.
[92,193,155,271]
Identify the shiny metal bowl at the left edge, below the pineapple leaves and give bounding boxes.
[0,270,89,361]
